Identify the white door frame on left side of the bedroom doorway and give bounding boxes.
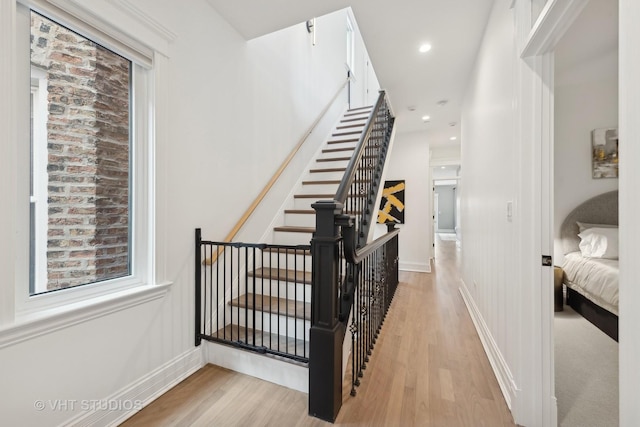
[516,0,589,427]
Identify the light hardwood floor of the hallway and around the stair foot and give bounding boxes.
[123,241,514,427]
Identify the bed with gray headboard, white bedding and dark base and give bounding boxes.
[560,191,619,341]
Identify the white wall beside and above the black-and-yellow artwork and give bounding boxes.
[376,133,433,271]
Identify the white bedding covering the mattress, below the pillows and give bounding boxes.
[562,252,619,315]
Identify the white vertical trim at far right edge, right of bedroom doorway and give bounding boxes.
[618,0,640,426]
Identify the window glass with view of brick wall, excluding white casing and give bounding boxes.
[29,11,132,295]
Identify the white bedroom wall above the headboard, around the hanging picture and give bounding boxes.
[554,51,618,265]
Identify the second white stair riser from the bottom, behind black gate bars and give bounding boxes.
[233,307,311,341]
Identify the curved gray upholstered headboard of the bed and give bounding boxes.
[560,190,618,254]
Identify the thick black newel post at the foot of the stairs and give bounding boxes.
[309,201,345,422]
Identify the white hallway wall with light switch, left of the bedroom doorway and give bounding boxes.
[459,1,533,425]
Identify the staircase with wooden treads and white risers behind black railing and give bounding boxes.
[197,107,372,392]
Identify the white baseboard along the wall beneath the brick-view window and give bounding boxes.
[62,346,204,427]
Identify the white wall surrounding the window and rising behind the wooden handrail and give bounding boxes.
[0,0,380,426]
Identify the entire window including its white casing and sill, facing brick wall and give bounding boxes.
[9,0,157,322]
